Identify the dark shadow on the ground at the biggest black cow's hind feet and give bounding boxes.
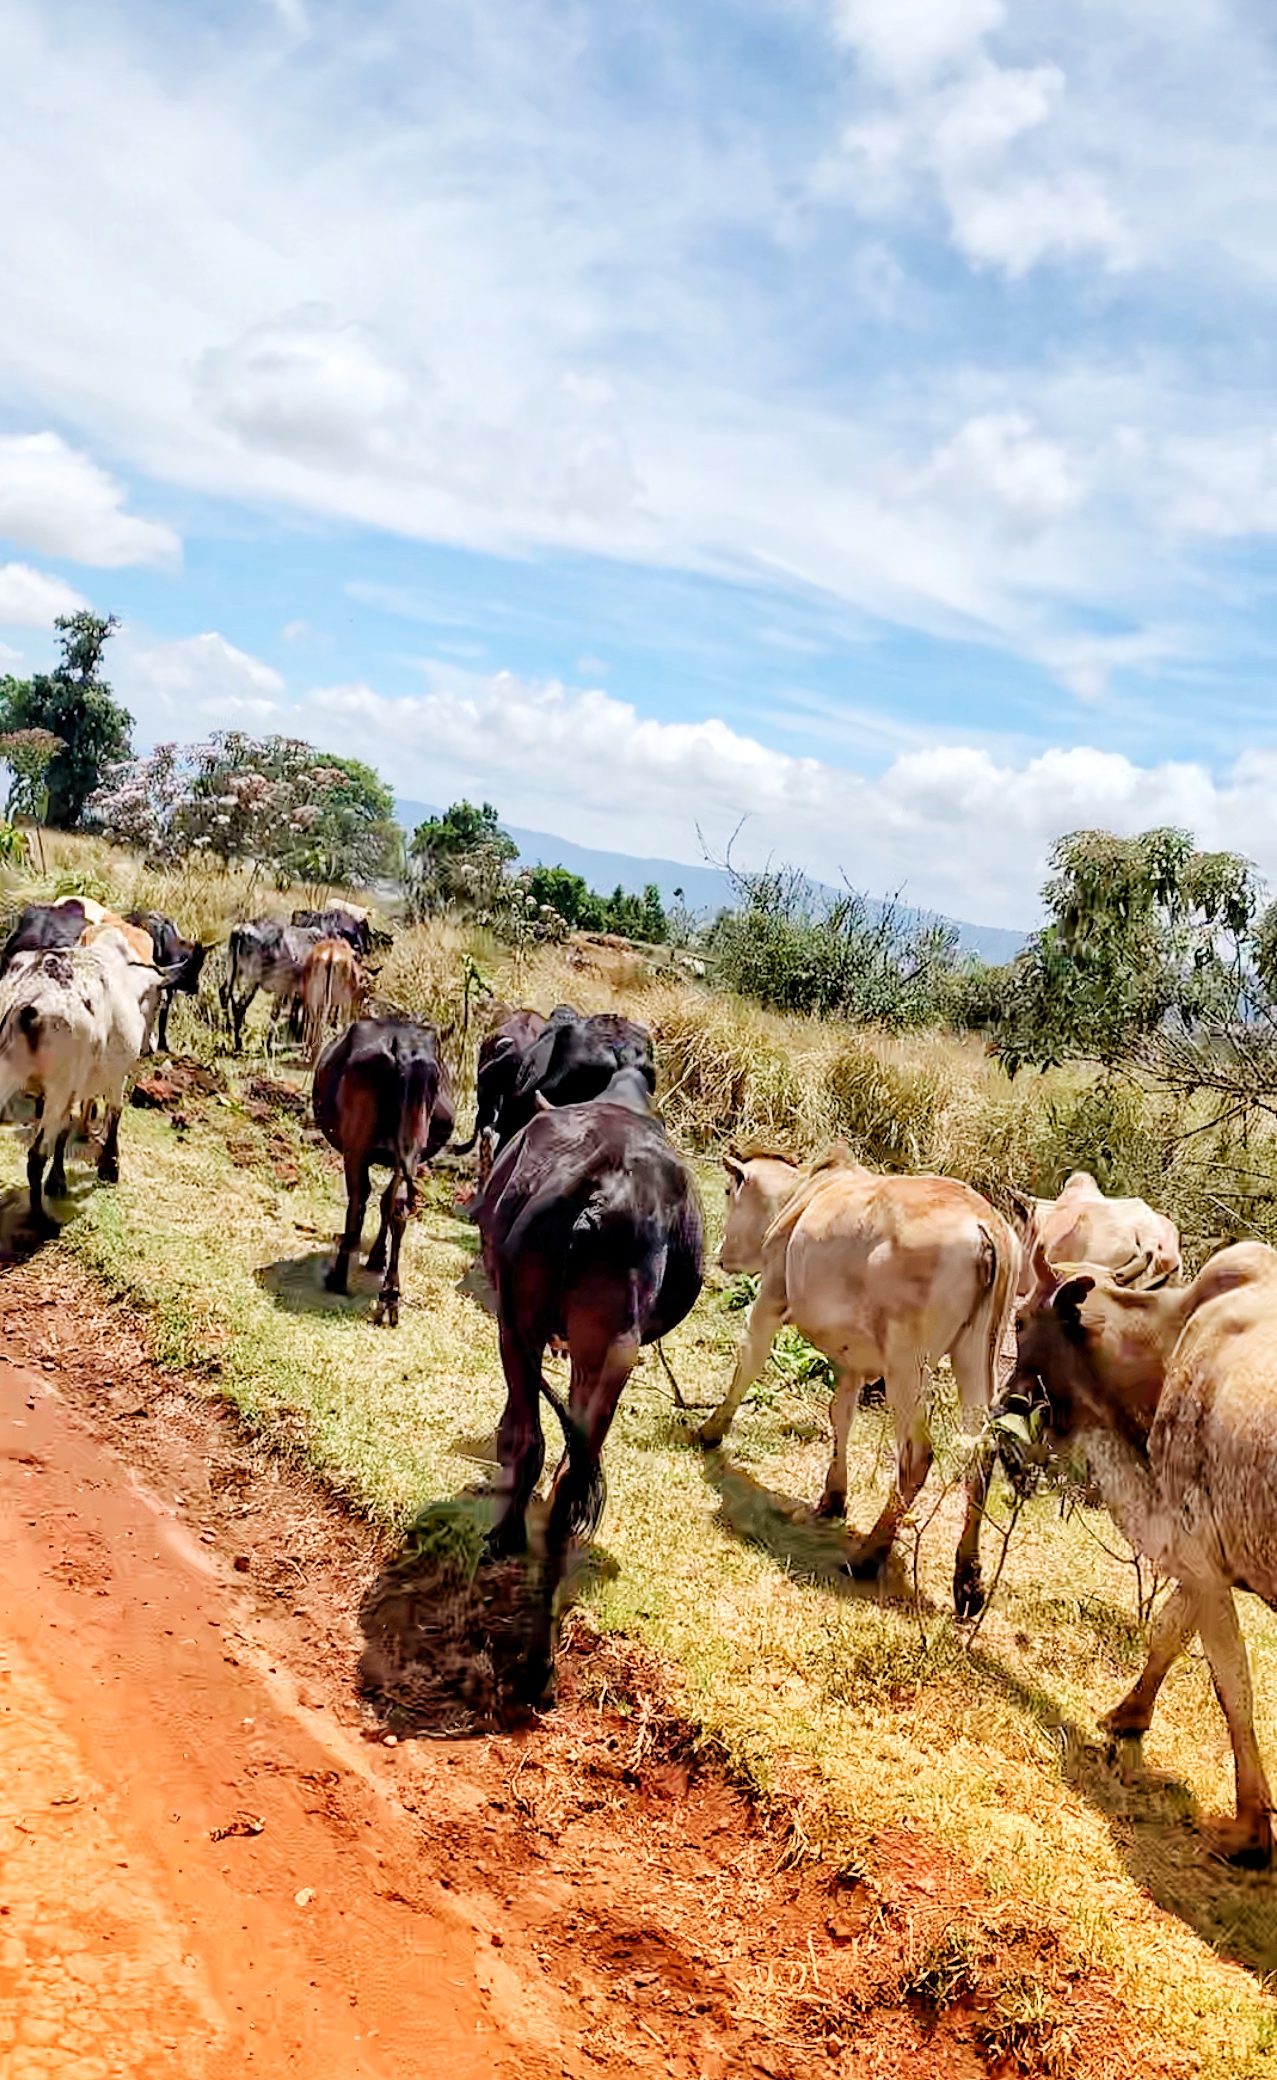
[360,1491,616,1741]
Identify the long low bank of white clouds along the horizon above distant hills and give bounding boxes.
[289,666,1277,928]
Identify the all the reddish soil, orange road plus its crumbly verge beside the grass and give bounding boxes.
[0,1252,1185,2080]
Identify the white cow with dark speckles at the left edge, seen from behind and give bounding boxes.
[0,930,160,1233]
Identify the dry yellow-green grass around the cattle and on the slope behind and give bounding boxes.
[0,840,1277,2076]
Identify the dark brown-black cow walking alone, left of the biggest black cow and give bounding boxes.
[314,1017,455,1329]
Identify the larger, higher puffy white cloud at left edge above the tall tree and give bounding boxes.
[0,433,181,570]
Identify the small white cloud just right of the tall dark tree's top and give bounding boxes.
[110,626,287,743]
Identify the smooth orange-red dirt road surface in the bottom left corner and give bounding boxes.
[0,1362,536,2080]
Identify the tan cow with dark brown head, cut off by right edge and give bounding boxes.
[1013,1242,1277,1864]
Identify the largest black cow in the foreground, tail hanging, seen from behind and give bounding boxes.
[474,1065,703,1704]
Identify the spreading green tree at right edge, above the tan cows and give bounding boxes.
[986,830,1277,1073]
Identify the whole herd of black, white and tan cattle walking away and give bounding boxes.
[0,899,1277,1864]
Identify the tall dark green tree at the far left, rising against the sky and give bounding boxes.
[0,612,133,830]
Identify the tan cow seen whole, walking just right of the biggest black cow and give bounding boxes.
[701,1146,1019,1616]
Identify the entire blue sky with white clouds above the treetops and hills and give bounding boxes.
[0,0,1277,926]
